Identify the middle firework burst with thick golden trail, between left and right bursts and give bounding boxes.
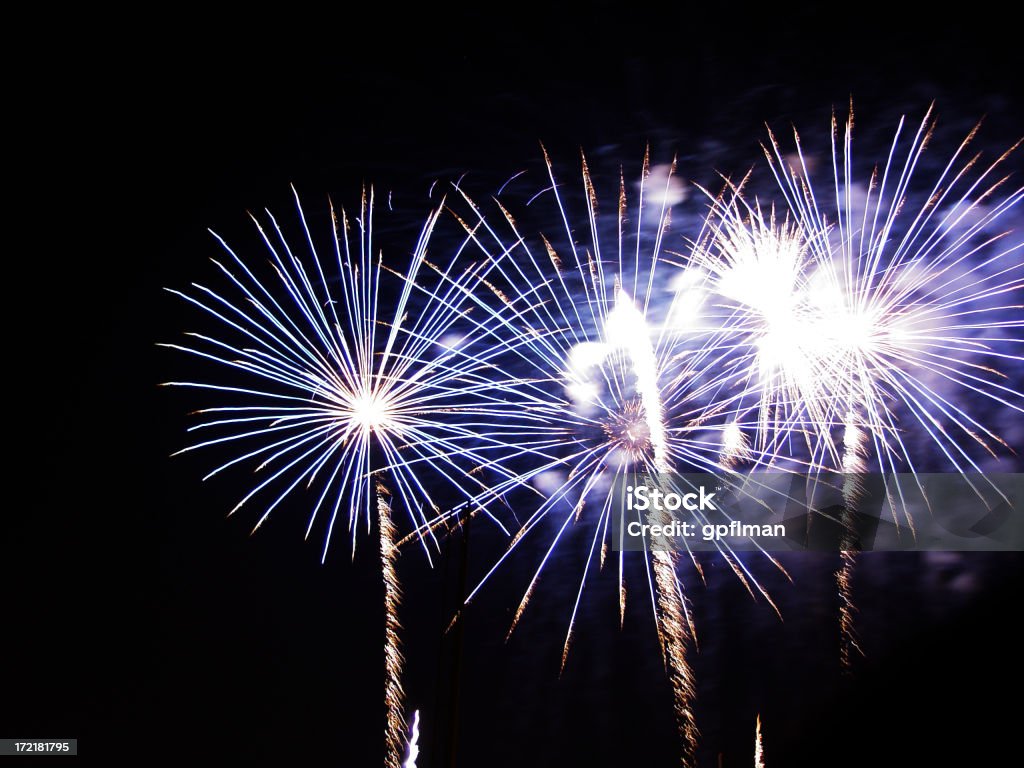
[423,145,790,761]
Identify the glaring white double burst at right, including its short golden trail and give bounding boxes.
[693,112,1024,666]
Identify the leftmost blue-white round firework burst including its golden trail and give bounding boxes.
[166,190,524,766]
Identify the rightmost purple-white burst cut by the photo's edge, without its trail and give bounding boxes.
[766,111,1024,481]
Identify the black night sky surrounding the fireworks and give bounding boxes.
[9,2,1024,768]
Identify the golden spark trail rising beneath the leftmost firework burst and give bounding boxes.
[377,484,403,768]
